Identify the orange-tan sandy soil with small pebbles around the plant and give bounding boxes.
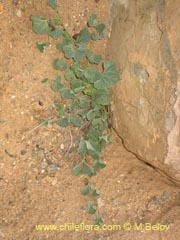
[0,0,180,240]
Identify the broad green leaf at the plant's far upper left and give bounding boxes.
[30,16,50,34]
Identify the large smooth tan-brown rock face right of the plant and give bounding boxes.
[108,0,180,181]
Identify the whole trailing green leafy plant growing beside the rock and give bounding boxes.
[31,0,120,225]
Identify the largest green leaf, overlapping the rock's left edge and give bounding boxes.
[94,61,120,89]
